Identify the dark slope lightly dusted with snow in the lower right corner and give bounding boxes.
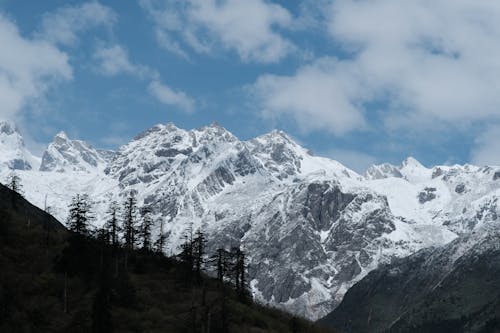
[320,233,500,333]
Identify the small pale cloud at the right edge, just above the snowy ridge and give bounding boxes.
[471,125,500,166]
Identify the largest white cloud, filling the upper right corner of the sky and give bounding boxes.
[330,0,500,121]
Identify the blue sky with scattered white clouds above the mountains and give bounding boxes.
[0,0,500,172]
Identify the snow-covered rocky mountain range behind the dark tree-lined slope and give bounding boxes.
[0,123,500,319]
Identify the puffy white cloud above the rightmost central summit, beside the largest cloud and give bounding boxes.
[251,58,365,135]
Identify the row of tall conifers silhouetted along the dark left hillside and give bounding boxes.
[66,192,251,300]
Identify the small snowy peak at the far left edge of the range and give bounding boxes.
[0,121,40,170]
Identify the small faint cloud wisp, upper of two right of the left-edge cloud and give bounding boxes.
[94,44,156,78]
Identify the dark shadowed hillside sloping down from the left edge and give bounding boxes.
[0,185,338,333]
